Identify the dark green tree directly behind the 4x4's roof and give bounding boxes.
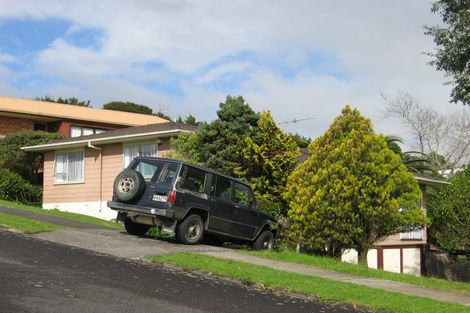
[196,96,258,175]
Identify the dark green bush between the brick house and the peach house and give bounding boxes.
[0,130,63,185]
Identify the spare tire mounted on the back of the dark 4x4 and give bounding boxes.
[114,169,145,202]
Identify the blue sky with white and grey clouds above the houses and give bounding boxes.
[0,0,456,142]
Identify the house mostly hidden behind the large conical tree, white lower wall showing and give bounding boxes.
[341,173,449,276]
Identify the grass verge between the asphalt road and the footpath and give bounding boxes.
[148,253,470,313]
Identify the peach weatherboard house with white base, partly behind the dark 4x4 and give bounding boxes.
[23,122,194,220]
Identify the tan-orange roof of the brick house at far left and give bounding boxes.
[0,97,168,126]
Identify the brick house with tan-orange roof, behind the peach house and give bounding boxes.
[0,97,168,137]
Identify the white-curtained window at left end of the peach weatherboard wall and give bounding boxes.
[54,151,84,184]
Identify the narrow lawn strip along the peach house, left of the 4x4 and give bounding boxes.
[0,200,124,230]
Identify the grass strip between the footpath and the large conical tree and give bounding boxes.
[242,250,470,295]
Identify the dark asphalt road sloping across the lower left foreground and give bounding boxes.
[0,229,354,313]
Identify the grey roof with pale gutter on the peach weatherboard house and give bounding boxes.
[22,122,196,151]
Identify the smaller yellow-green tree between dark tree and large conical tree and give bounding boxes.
[234,111,300,215]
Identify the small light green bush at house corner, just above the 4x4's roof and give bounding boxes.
[165,133,200,164]
